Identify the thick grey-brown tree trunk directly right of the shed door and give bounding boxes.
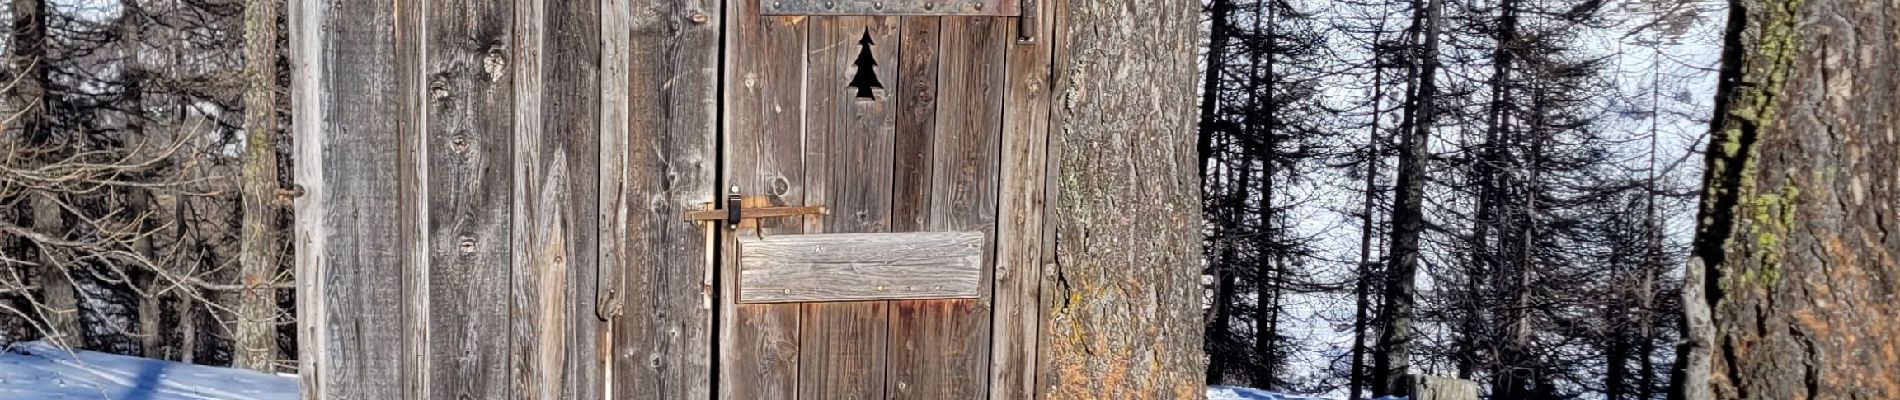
[1043,0,1205,400]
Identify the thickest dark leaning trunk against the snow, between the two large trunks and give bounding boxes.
[1372,0,1444,396]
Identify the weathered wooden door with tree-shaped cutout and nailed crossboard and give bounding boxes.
[716,0,1017,400]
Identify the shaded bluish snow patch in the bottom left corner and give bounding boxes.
[0,341,296,400]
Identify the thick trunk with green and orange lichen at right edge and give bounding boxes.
[1676,0,1900,398]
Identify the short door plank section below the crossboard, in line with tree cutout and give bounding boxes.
[798,301,889,400]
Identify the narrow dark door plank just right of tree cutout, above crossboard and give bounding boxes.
[887,17,942,231]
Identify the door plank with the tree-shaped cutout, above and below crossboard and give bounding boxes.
[790,17,897,398]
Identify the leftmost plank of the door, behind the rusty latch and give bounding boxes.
[716,0,808,398]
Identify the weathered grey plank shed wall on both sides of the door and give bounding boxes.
[289,0,1056,400]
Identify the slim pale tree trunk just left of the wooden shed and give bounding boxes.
[232,0,283,372]
